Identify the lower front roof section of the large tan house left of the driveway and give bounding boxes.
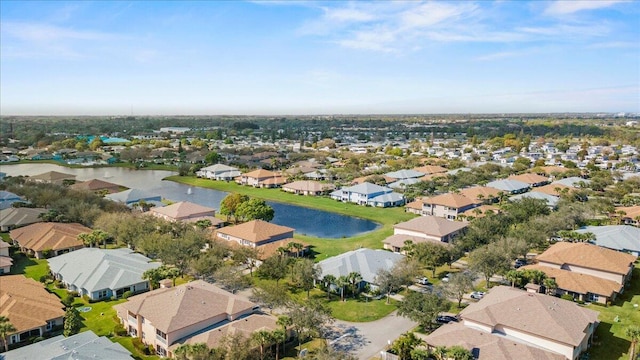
[170,314,279,351]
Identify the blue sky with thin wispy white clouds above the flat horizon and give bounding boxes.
[0,0,640,115]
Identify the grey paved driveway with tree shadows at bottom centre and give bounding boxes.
[328,311,418,360]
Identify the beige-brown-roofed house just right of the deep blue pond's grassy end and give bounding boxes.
[383,215,468,252]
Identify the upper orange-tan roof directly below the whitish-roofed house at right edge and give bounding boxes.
[536,242,636,275]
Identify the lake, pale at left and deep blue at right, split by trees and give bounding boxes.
[0,164,380,239]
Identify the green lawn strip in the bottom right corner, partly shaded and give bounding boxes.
[587,263,640,360]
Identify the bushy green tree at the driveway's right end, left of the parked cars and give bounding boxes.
[398,291,449,330]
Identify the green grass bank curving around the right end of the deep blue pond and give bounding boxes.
[165,176,415,261]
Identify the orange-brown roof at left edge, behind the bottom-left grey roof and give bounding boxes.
[0,275,64,333]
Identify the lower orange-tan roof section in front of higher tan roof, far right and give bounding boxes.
[520,265,622,297]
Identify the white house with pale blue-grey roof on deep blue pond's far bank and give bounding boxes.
[330,182,404,207]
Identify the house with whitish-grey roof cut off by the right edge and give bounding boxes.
[576,225,640,256]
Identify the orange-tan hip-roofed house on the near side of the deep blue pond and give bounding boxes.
[215,220,294,248]
